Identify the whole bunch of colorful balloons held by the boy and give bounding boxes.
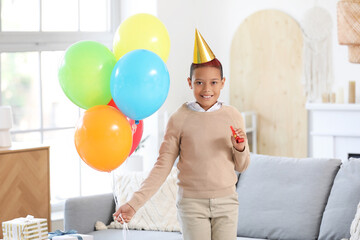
[58,13,170,172]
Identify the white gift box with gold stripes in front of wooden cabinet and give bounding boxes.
[2,215,48,240]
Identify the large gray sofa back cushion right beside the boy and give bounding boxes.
[237,154,341,240]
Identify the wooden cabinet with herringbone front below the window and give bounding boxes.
[0,143,51,238]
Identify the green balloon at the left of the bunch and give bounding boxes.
[58,41,116,109]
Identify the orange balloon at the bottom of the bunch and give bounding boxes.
[75,105,132,172]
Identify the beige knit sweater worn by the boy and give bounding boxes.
[128,103,250,211]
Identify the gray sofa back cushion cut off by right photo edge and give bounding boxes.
[319,158,360,240]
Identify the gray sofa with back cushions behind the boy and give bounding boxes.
[65,155,360,240]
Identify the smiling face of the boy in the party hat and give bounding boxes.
[188,67,225,111]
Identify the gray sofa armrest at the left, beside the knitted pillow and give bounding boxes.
[64,193,115,234]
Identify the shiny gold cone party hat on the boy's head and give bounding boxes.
[193,29,215,64]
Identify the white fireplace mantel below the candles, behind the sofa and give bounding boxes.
[306,103,360,162]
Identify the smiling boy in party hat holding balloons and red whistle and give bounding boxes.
[114,30,250,240]
